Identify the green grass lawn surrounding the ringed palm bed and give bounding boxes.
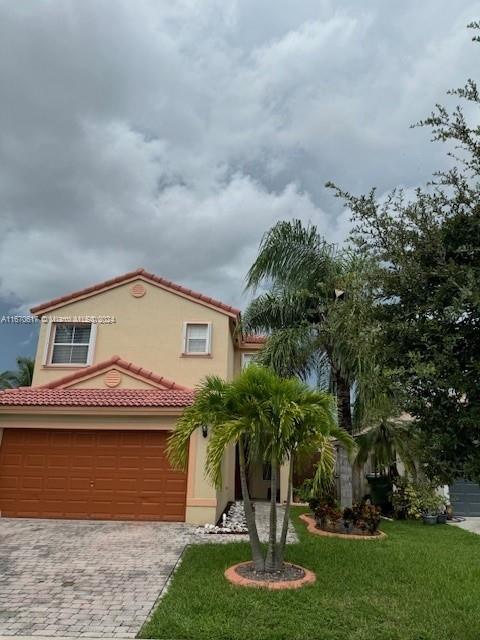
[140,508,480,640]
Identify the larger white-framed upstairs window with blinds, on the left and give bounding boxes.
[49,323,94,365]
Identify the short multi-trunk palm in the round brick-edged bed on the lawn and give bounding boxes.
[168,365,354,572]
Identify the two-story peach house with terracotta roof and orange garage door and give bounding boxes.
[0,269,286,523]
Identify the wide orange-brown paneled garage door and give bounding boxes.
[0,429,186,522]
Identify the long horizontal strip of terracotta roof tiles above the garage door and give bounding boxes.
[0,387,194,407]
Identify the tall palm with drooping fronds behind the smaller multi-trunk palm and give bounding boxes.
[242,220,378,433]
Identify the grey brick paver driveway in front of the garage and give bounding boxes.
[0,518,193,638]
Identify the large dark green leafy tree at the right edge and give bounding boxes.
[329,23,480,481]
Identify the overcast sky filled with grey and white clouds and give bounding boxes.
[0,0,480,371]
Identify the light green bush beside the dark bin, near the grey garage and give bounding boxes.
[392,478,446,520]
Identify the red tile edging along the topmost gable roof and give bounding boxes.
[31,269,240,318]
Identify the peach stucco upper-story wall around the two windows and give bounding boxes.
[33,282,233,387]
